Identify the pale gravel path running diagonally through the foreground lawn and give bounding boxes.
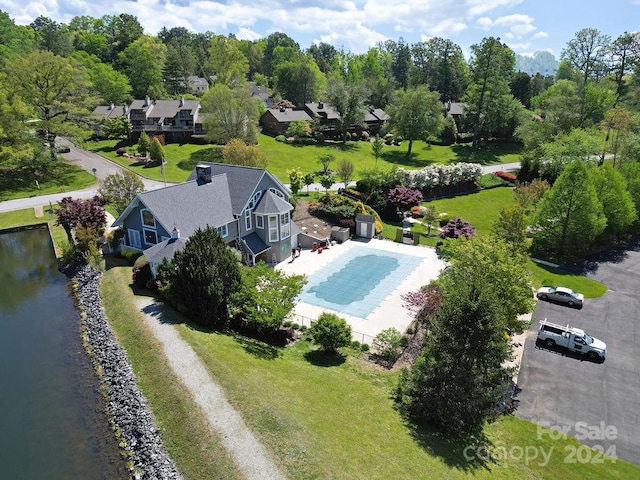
[138,299,285,480]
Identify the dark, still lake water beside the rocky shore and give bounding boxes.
[0,228,129,480]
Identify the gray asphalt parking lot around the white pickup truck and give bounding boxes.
[515,244,640,464]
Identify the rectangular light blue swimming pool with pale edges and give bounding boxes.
[299,247,425,318]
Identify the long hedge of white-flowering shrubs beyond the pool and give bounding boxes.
[396,163,482,190]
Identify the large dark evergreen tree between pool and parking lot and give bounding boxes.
[396,275,510,436]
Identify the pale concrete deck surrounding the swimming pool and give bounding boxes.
[276,239,445,344]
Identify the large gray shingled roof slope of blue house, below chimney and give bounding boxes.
[131,175,235,238]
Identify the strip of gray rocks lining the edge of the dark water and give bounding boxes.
[63,265,181,480]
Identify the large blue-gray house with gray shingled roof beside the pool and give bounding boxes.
[113,162,300,272]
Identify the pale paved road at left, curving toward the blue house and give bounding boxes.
[0,139,169,212]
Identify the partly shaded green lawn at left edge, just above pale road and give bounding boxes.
[0,159,96,200]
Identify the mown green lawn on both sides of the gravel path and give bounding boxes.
[103,267,640,480]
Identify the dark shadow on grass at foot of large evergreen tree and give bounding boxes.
[407,424,497,473]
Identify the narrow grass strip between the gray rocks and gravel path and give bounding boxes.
[101,261,242,480]
